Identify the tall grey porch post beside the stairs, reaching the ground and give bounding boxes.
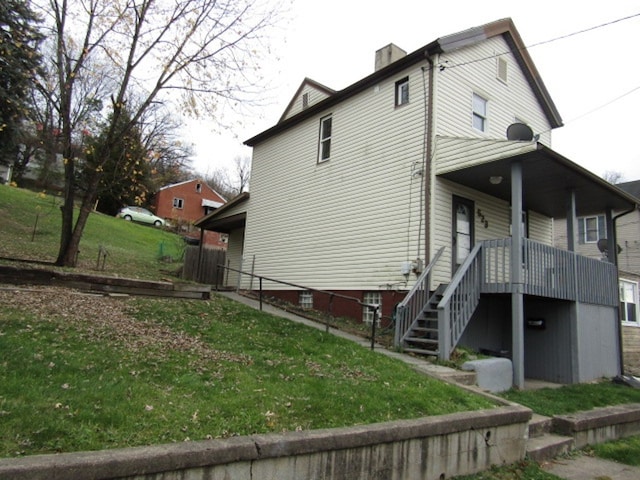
[511,161,524,389]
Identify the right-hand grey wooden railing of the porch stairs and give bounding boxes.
[438,243,482,360]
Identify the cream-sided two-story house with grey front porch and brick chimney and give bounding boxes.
[196,19,635,387]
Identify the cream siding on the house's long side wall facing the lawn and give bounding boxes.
[245,65,424,290]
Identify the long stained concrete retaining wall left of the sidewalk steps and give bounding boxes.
[0,405,531,480]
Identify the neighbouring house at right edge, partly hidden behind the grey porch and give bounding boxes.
[555,180,640,375]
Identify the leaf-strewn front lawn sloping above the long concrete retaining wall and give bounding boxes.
[0,288,494,456]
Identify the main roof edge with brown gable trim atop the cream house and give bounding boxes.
[244,18,562,146]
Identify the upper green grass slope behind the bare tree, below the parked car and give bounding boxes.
[0,185,185,280]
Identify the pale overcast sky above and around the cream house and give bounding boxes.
[189,0,640,181]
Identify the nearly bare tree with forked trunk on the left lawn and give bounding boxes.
[34,0,279,266]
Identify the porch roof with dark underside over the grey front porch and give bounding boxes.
[438,141,638,218]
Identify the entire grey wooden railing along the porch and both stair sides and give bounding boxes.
[395,238,618,360]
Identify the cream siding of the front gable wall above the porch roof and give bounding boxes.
[434,37,551,147]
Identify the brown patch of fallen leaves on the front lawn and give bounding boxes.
[0,286,251,364]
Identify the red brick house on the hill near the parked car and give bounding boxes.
[153,178,227,248]
